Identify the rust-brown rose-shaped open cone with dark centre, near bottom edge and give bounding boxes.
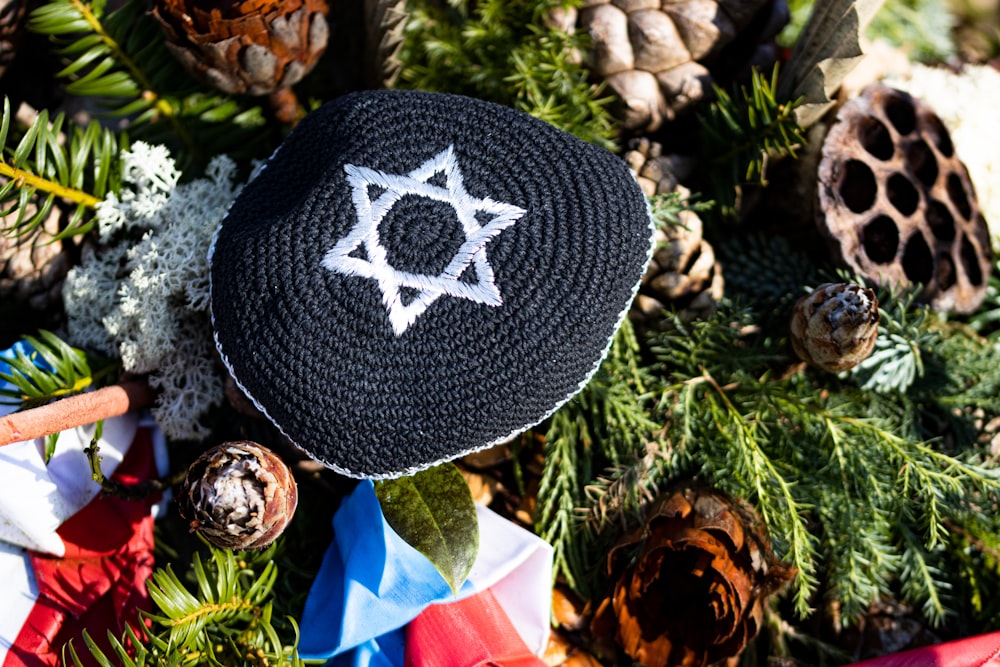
[591,486,794,667]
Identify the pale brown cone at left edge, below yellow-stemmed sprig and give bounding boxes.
[0,202,70,311]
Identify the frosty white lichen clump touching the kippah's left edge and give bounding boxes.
[63,142,239,439]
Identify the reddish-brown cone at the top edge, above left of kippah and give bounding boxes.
[153,0,330,95]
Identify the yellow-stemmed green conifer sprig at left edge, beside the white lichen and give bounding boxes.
[0,98,128,239]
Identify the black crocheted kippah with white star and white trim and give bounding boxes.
[211,91,652,478]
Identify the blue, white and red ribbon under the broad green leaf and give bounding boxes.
[299,480,552,667]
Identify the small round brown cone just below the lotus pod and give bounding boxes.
[789,283,879,373]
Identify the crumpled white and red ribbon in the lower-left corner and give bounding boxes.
[0,344,165,667]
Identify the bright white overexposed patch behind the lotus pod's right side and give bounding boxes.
[885,64,1000,251]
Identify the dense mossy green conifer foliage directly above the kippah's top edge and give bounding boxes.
[398,0,617,148]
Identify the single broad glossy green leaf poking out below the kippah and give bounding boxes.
[375,463,479,594]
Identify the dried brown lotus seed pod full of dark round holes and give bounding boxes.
[817,83,992,313]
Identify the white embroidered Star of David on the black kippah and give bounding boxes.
[322,146,525,336]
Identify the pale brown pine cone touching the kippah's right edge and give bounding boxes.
[629,187,725,330]
